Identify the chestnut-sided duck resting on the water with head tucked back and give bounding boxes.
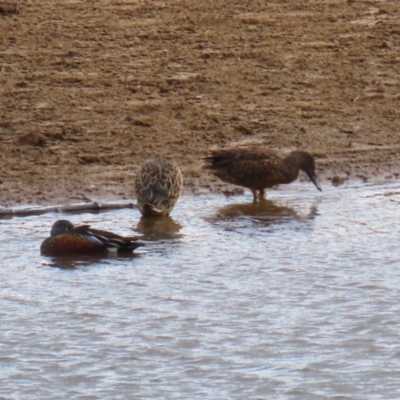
[40,219,144,256]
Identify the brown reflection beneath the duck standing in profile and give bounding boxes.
[211,199,317,225]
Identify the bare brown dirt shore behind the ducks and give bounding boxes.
[0,0,400,207]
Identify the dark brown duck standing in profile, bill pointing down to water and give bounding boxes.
[204,148,321,201]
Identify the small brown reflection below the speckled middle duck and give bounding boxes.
[133,216,182,240]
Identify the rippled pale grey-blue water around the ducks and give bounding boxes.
[0,183,400,399]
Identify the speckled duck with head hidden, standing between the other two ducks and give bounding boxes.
[135,157,183,217]
